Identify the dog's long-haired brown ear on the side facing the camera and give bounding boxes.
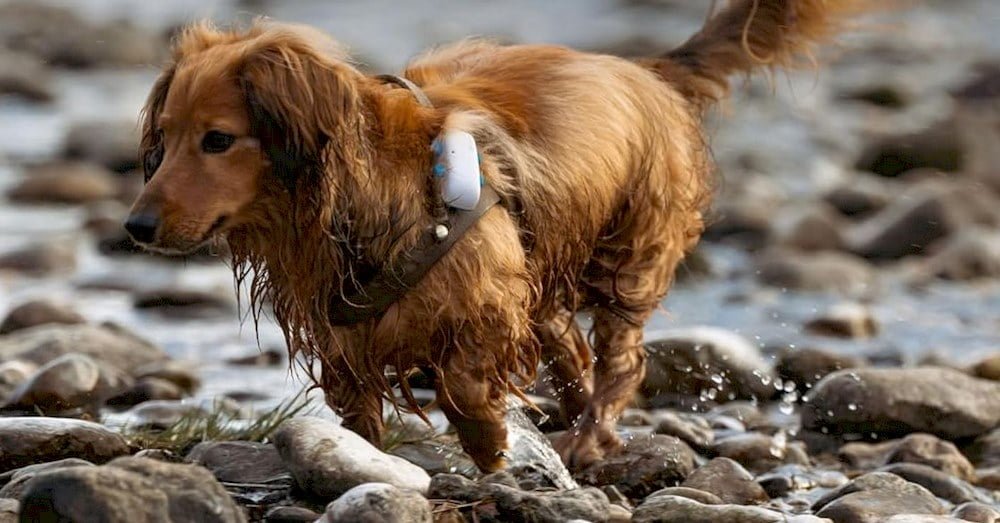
[239,27,361,188]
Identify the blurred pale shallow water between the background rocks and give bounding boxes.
[0,0,1000,414]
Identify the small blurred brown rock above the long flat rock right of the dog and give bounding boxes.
[772,202,847,252]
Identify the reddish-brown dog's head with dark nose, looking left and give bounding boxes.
[125,22,361,252]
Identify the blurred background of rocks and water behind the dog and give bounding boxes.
[0,0,1000,418]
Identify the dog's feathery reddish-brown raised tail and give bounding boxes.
[642,0,873,108]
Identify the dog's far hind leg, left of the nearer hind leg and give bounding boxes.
[535,307,593,425]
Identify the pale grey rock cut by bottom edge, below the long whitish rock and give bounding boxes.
[326,483,433,523]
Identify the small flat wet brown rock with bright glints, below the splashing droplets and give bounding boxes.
[712,432,809,474]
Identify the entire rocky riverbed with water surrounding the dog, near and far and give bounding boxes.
[0,0,1000,523]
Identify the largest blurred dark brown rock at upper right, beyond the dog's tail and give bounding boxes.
[855,122,964,178]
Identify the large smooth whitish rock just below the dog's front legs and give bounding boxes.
[273,417,430,499]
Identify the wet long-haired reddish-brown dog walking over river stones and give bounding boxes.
[125,0,866,471]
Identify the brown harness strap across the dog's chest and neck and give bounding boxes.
[329,75,500,327]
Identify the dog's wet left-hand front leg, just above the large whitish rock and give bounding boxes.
[322,362,383,447]
